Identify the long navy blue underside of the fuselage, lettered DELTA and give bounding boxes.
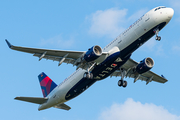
[65,22,166,100]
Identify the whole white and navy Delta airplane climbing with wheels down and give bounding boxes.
[5,6,174,111]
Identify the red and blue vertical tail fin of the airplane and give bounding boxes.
[38,72,57,97]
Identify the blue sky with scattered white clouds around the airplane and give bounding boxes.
[0,0,180,120]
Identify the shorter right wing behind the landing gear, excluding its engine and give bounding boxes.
[111,59,168,84]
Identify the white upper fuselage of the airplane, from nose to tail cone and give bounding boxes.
[39,7,174,110]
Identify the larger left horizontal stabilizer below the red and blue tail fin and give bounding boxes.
[14,97,48,104]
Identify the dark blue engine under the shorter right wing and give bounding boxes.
[136,57,154,74]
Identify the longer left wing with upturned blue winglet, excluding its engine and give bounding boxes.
[6,40,107,69]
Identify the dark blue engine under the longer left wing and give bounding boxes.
[84,45,102,62]
